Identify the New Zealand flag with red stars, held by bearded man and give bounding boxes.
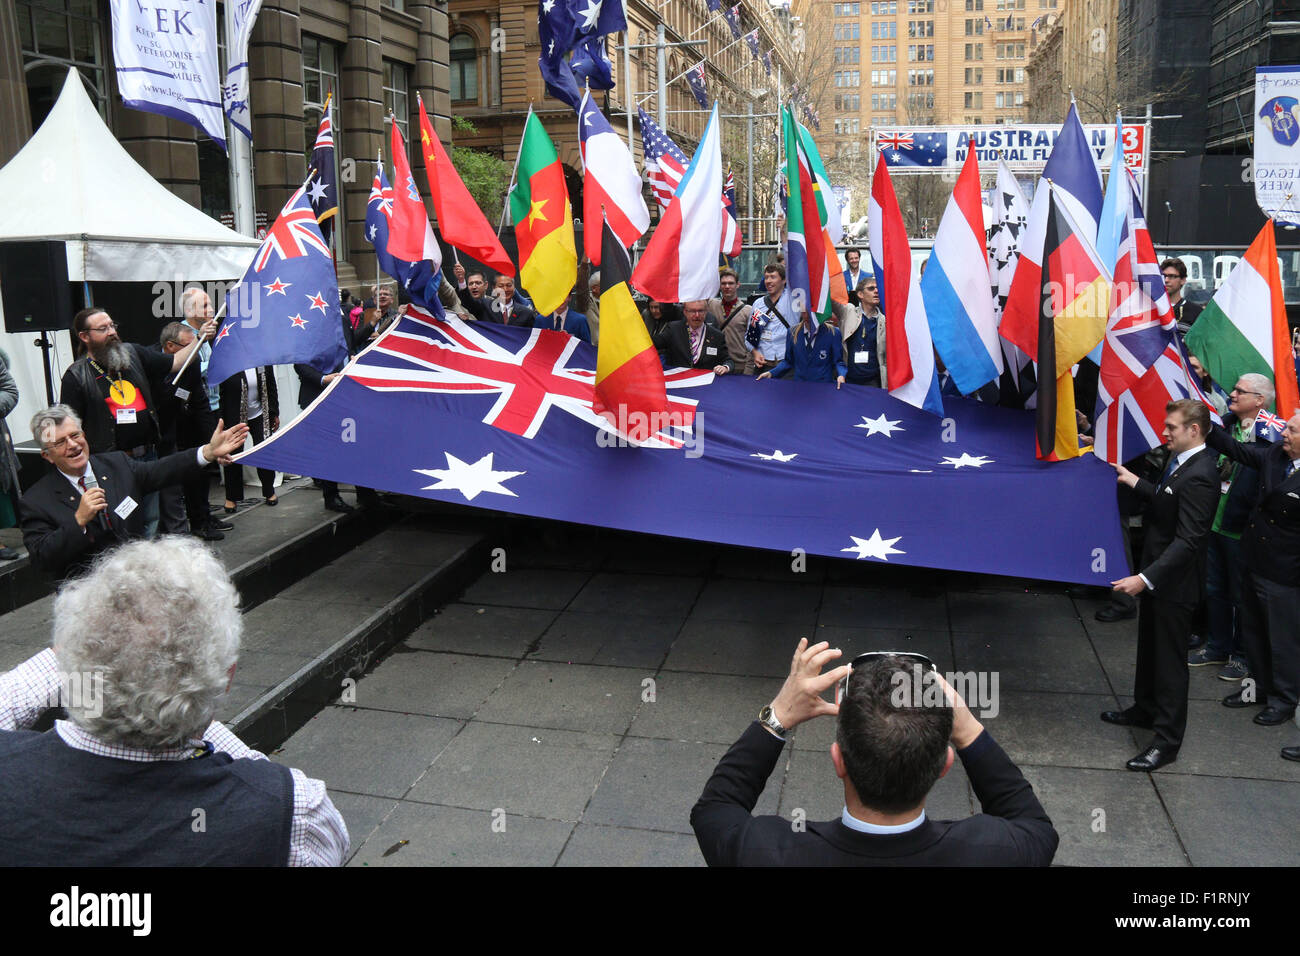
[208,179,347,384]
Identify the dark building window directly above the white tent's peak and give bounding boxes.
[16,0,108,130]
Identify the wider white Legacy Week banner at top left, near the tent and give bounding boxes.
[111,0,226,150]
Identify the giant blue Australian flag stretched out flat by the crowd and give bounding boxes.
[241,308,1128,585]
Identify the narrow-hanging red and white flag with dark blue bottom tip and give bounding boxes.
[867,163,941,415]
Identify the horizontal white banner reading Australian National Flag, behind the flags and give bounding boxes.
[876,124,1147,173]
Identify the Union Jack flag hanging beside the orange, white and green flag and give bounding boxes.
[1093,170,1221,464]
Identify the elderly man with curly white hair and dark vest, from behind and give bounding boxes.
[0,537,348,866]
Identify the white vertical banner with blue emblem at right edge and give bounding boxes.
[1255,66,1300,225]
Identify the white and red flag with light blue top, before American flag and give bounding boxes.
[632,103,723,302]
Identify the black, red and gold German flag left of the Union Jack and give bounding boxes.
[1037,183,1110,462]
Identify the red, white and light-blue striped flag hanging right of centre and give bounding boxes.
[915,150,1002,395]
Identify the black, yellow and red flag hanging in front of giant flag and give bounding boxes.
[592,216,668,442]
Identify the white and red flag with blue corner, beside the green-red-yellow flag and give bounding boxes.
[577,91,650,265]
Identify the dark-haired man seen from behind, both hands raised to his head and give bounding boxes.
[690,639,1058,866]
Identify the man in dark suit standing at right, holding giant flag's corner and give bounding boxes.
[1101,398,1219,771]
